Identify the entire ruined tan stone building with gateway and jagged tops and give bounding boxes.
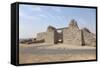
[33,20,96,46]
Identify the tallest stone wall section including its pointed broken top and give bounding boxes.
[63,20,82,46]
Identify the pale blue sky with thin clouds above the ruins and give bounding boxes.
[19,4,96,38]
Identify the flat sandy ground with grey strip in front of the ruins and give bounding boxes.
[19,43,96,64]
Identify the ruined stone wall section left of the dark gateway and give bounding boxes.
[36,27,57,44]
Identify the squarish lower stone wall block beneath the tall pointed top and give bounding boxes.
[63,28,82,45]
